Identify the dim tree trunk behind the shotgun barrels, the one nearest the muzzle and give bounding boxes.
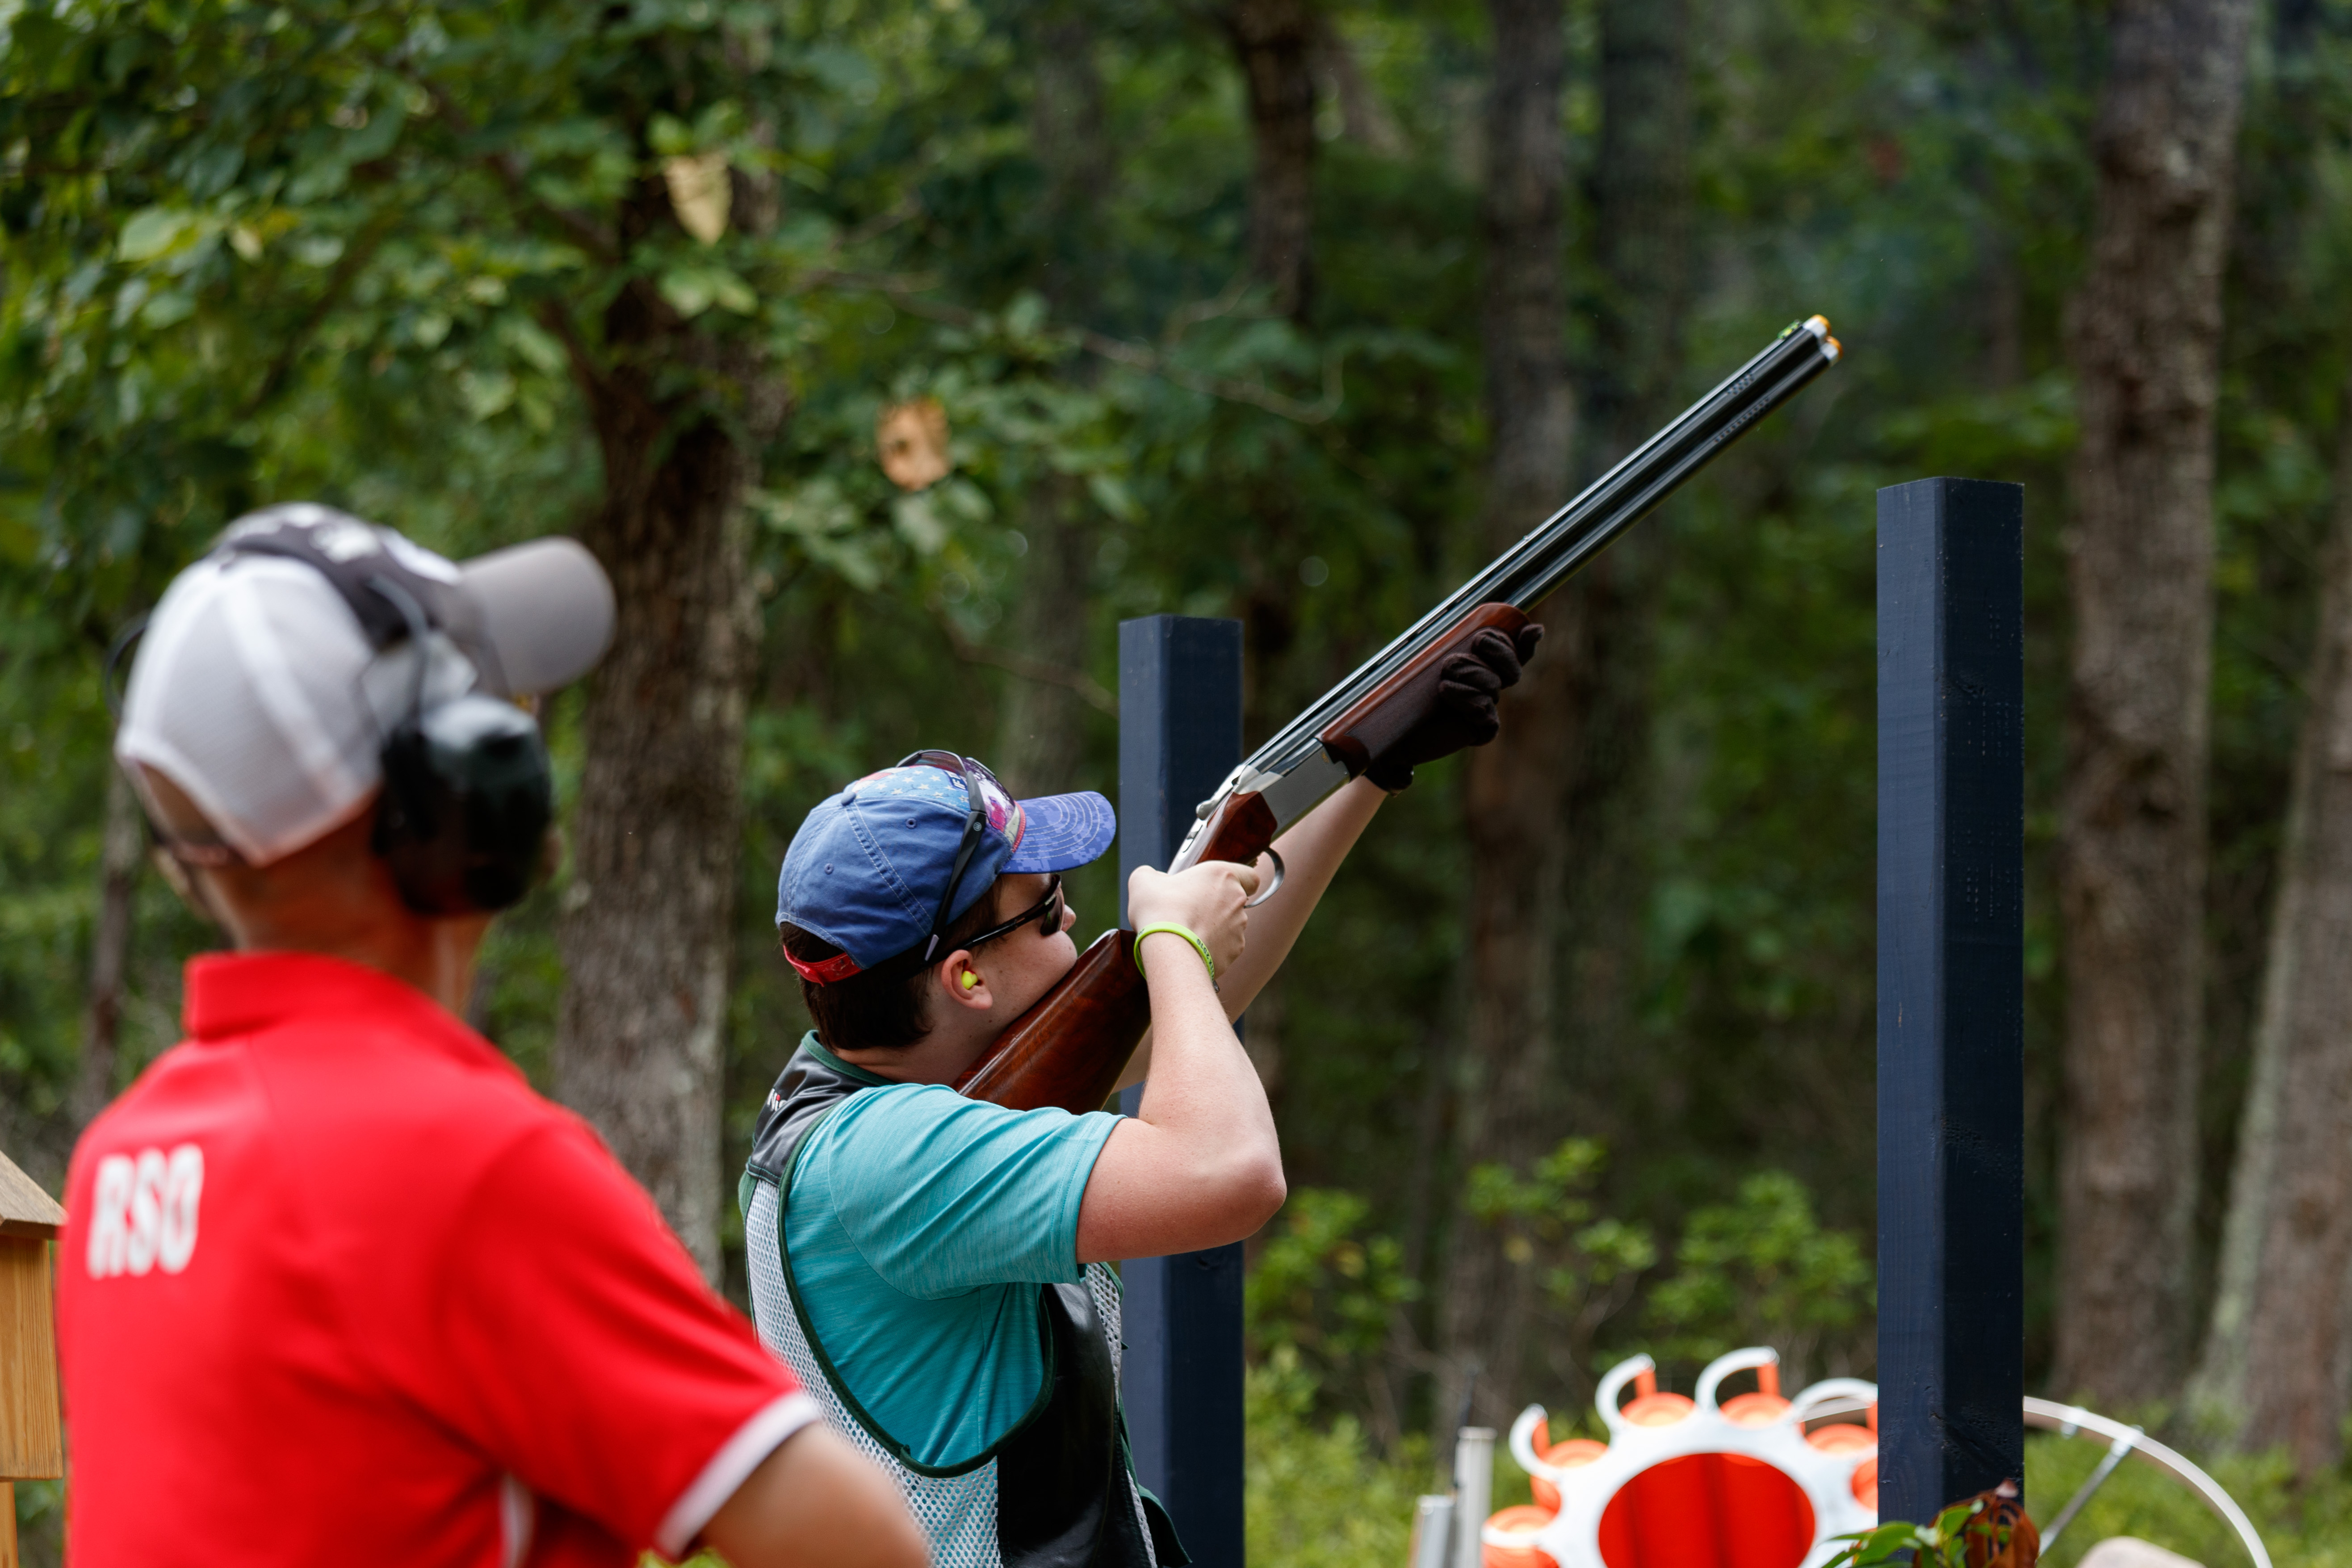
[1547,0,1691,1114]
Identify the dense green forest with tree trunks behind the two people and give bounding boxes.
[0,0,2352,1542]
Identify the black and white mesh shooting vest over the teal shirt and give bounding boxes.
[738,1051,1186,1568]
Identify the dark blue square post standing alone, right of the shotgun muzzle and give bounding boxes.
[1879,480,2025,1523]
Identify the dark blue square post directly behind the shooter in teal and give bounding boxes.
[1119,616,1242,1568]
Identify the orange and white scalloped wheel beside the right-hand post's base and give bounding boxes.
[1480,1347,1879,1568]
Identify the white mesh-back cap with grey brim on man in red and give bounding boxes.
[115,505,614,865]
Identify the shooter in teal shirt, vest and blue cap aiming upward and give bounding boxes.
[741,628,1541,1568]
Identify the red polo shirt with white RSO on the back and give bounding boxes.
[59,952,816,1568]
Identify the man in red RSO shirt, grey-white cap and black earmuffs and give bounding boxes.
[56,505,922,1568]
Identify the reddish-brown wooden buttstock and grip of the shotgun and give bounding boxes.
[955,795,1275,1114]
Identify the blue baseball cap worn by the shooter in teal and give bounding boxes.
[776,759,1119,985]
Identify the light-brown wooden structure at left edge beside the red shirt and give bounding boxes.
[0,1154,66,1568]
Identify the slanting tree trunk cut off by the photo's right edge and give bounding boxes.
[2194,386,2352,1479]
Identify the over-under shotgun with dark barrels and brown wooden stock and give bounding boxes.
[955,315,1839,1112]
